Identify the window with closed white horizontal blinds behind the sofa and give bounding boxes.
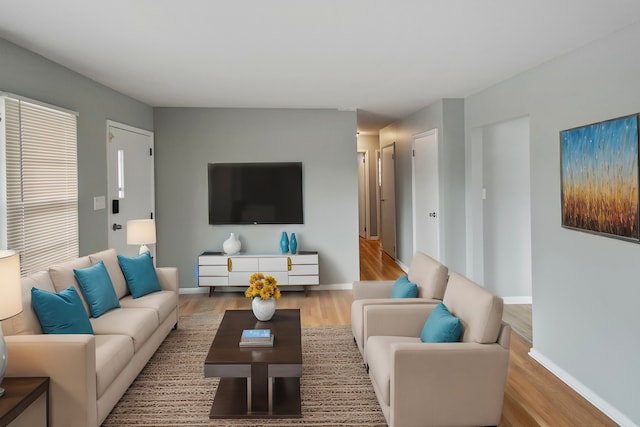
[0,95,79,275]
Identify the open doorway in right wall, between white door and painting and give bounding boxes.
[482,117,532,298]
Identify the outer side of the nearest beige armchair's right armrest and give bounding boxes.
[390,343,509,425]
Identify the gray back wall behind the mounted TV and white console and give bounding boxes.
[154,108,359,288]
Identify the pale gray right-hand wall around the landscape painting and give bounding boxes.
[465,24,640,425]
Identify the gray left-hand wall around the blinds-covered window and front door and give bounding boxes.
[0,39,153,255]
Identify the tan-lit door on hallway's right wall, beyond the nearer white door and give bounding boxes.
[380,143,396,259]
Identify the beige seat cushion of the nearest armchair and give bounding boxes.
[367,336,420,406]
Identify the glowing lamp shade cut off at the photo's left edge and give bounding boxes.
[0,250,22,320]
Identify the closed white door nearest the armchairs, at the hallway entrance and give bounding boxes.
[412,129,441,261]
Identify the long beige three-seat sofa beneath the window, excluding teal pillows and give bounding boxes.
[2,249,178,427]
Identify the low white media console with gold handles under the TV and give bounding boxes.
[198,251,320,295]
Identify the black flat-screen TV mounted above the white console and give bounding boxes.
[208,162,303,225]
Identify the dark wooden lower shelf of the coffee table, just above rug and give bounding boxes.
[209,377,302,419]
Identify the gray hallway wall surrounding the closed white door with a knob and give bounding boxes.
[380,99,466,272]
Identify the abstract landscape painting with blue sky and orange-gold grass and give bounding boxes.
[560,115,640,242]
